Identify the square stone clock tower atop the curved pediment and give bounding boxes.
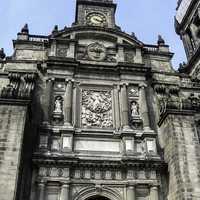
[74,0,116,28]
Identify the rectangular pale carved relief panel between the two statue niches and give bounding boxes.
[81,90,113,128]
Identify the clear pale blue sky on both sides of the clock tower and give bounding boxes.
[0,0,186,68]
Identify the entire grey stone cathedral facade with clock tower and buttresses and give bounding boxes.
[0,0,200,200]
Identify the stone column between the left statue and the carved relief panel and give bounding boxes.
[64,80,72,126]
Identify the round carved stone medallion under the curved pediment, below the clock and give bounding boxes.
[87,42,106,61]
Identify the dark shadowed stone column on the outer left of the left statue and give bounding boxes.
[43,79,53,124]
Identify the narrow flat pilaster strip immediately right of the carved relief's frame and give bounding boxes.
[114,85,120,130]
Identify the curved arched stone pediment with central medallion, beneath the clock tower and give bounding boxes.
[51,28,143,64]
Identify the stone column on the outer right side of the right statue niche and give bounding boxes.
[140,85,150,131]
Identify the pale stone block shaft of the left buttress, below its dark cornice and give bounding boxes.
[0,105,27,200]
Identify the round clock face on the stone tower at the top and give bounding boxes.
[86,13,106,26]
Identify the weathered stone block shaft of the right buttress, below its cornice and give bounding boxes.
[162,114,200,200]
